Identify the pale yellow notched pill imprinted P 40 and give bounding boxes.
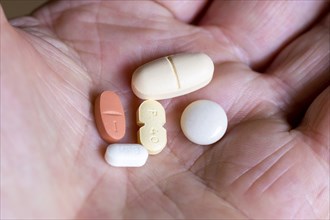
[137,100,167,154]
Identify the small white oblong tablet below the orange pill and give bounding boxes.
[104,144,148,167]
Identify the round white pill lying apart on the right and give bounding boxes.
[180,100,228,145]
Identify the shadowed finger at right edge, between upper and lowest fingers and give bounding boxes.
[267,12,330,125]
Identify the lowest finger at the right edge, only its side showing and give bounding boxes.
[298,87,330,163]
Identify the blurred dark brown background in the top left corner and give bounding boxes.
[0,0,47,19]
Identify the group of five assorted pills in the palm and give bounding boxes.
[94,53,228,167]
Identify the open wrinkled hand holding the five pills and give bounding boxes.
[0,1,330,219]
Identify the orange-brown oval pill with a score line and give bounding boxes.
[94,91,126,143]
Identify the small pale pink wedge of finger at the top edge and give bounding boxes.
[156,0,207,22]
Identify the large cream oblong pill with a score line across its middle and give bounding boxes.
[131,53,214,100]
